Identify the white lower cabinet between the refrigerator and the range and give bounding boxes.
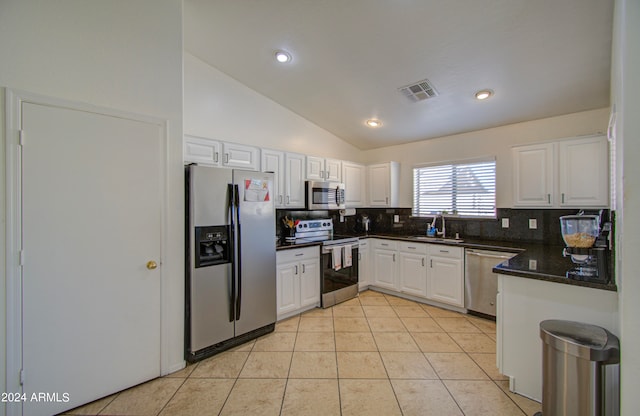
[276,246,320,320]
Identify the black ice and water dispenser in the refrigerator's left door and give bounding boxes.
[195,225,231,269]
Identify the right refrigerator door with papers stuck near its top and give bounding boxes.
[233,170,276,336]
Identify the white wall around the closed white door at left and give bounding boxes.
[0,0,184,414]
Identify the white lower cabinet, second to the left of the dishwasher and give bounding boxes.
[399,242,427,297]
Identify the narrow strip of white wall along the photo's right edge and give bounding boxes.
[611,0,640,416]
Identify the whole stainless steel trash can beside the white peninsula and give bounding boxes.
[540,320,620,416]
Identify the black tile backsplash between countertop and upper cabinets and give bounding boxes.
[276,208,612,245]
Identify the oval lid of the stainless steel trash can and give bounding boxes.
[540,319,620,364]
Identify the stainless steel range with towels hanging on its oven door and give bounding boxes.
[296,218,358,308]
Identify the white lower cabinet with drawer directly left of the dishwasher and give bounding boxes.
[427,244,464,308]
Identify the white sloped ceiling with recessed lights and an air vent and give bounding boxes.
[184,0,613,149]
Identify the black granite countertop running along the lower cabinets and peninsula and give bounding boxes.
[276,233,617,291]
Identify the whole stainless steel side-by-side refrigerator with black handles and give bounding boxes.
[185,165,276,362]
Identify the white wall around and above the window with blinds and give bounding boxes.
[363,108,609,208]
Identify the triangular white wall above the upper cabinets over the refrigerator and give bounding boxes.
[184,52,361,162]
